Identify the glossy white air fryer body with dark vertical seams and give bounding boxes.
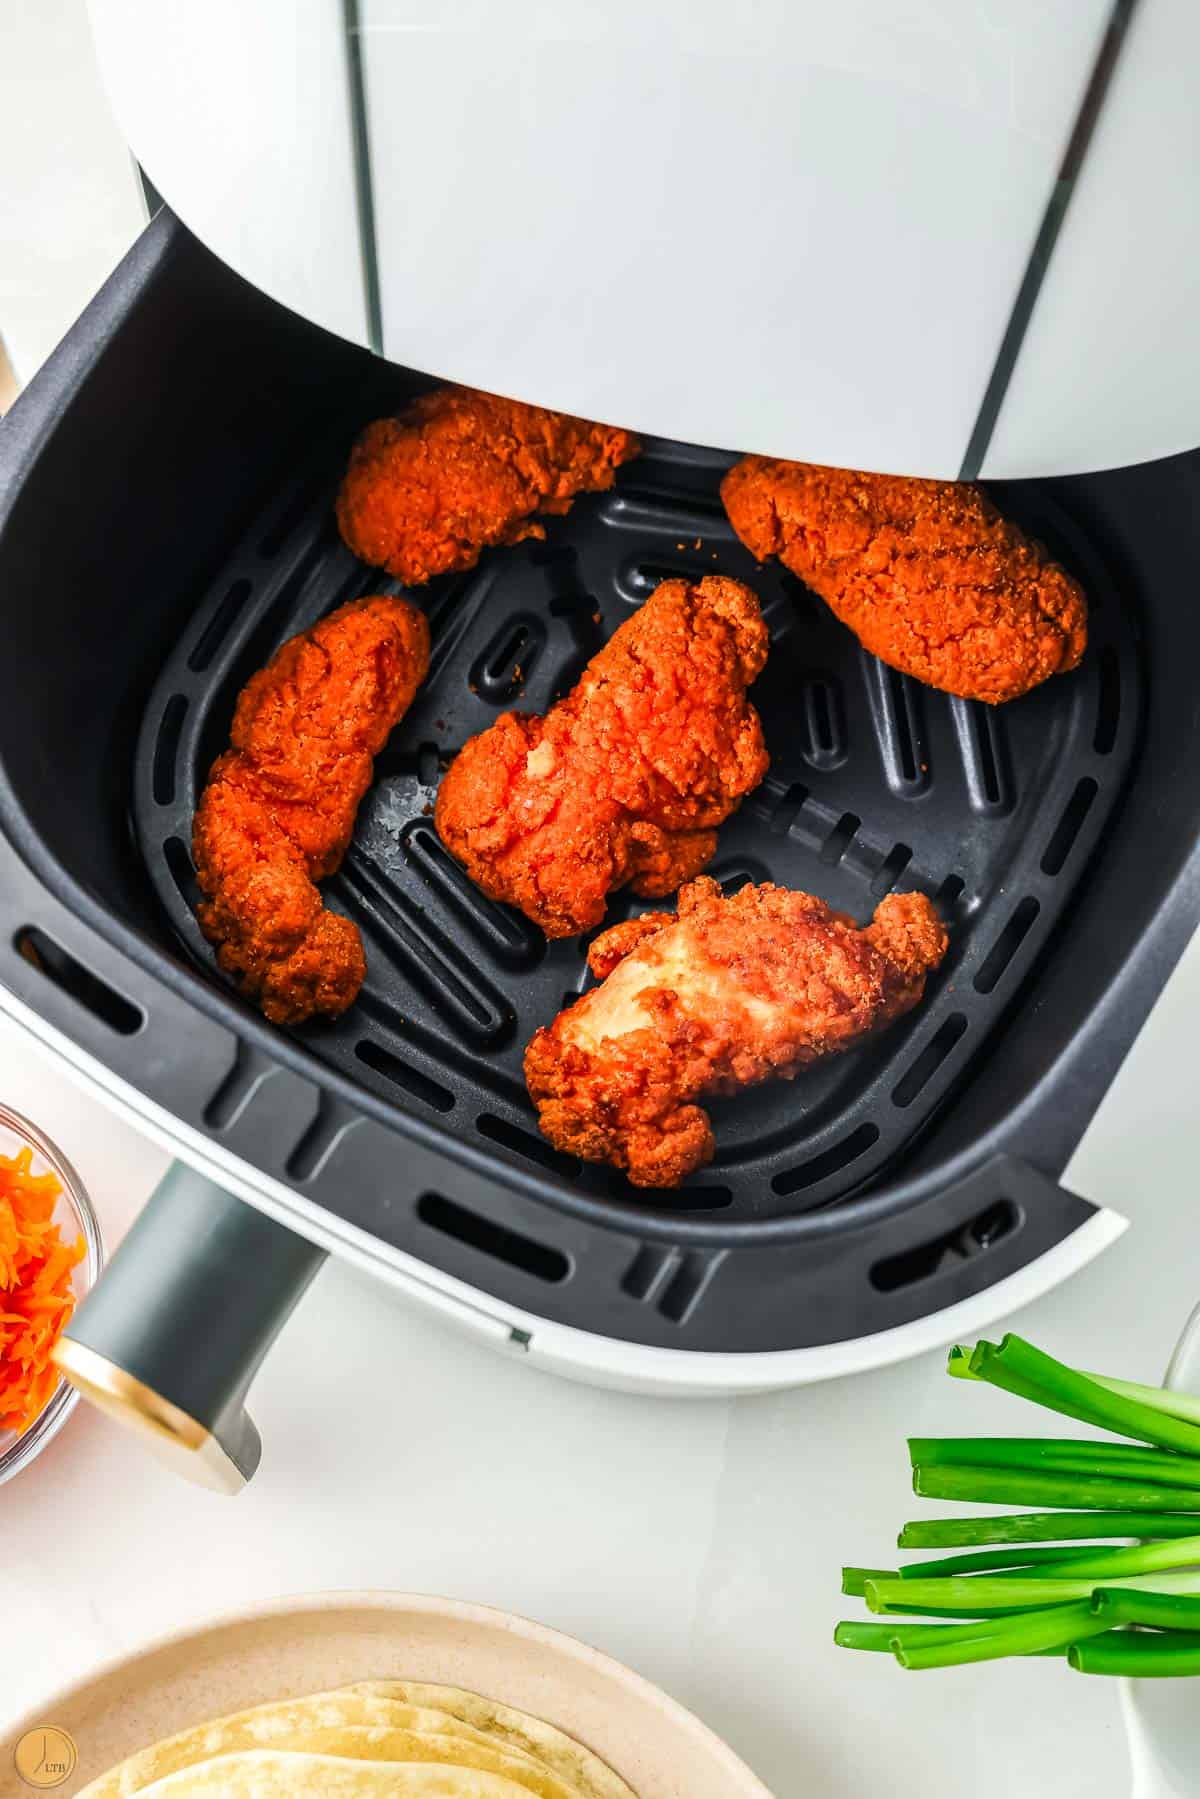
[90,0,1200,477]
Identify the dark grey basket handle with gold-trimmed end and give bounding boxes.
[54,1162,326,1493]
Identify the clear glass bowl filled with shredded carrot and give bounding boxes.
[0,1105,104,1482]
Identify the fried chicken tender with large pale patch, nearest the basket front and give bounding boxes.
[525,876,946,1187]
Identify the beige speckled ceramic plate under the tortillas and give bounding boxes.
[0,1592,770,1799]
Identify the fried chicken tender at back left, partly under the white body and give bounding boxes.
[336,387,639,585]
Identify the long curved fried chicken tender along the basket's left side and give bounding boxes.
[193,597,430,1024]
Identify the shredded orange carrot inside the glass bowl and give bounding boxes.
[0,1146,85,1430]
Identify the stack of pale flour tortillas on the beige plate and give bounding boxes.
[79,1680,635,1799]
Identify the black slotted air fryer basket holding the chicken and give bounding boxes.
[0,212,1200,1475]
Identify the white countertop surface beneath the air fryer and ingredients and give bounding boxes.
[0,0,1200,1799]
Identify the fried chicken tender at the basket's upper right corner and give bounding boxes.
[721,455,1087,705]
